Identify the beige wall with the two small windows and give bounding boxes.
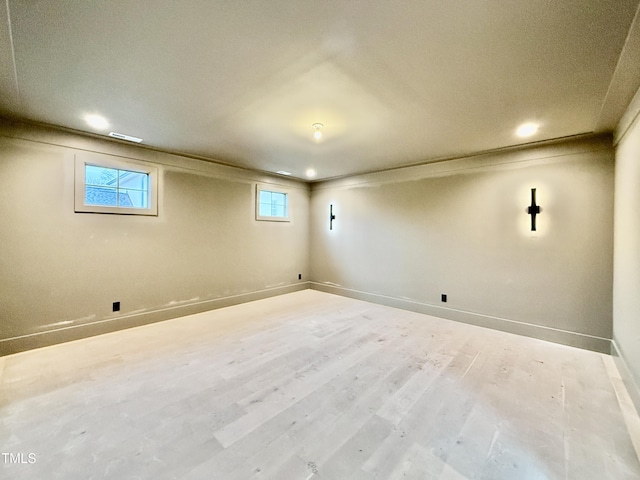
[0,122,309,354]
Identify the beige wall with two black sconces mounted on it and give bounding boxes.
[310,137,614,351]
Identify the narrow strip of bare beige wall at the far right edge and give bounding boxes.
[613,87,640,408]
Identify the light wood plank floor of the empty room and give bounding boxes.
[0,290,640,480]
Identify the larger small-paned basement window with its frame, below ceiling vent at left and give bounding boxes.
[75,155,158,215]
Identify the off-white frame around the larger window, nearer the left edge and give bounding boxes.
[74,154,158,216]
